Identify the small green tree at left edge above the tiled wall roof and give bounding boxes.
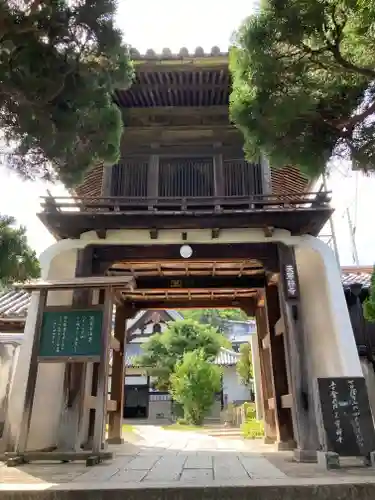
[0,215,40,287]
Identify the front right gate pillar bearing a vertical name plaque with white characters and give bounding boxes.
[279,244,319,461]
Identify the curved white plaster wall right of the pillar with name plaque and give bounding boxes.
[296,236,362,377]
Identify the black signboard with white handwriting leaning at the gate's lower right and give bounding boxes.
[318,377,375,456]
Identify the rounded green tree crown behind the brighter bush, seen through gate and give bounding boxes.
[137,320,226,390]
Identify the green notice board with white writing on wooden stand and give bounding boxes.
[39,310,103,361]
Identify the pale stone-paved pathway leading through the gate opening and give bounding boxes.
[0,426,374,490]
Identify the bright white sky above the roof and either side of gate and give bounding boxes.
[0,0,375,265]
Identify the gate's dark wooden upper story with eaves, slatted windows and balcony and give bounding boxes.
[39,49,332,238]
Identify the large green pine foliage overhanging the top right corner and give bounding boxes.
[230,0,375,176]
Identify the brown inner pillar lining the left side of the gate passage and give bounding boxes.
[108,305,127,444]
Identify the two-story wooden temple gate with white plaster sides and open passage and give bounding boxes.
[2,47,374,460]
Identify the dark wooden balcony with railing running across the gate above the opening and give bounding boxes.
[39,188,332,239]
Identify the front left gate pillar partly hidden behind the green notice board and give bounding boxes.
[57,247,93,451]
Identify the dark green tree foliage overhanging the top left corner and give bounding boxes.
[0,0,132,186]
